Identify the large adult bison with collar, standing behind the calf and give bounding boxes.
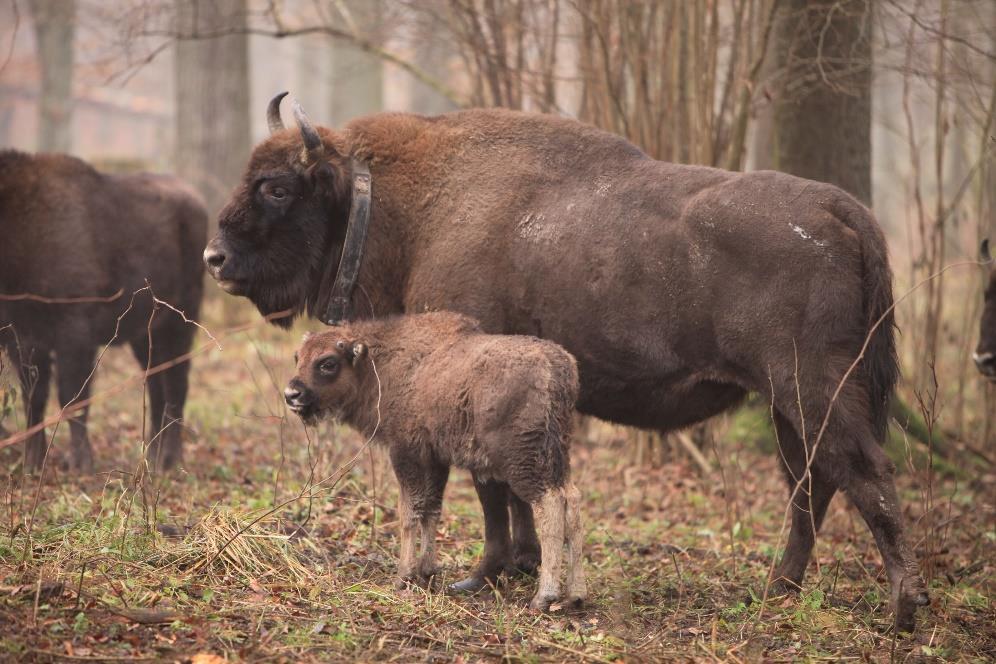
[204,95,928,629]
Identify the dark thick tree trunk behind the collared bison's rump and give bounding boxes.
[773,0,872,205]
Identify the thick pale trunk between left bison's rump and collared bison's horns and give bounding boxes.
[174,0,252,223]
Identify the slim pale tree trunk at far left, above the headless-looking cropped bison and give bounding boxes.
[31,0,76,152]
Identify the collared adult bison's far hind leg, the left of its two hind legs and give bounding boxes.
[771,412,837,594]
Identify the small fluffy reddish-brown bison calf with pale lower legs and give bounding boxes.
[284,312,586,610]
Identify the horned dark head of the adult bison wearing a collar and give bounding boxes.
[204,92,350,327]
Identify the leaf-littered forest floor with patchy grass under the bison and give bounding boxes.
[0,302,996,662]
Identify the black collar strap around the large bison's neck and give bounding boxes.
[322,159,372,325]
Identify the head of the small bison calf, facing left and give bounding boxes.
[284,328,367,424]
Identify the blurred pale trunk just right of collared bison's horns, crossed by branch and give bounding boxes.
[329,0,384,127]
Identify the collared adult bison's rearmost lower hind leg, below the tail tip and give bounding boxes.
[843,441,930,632]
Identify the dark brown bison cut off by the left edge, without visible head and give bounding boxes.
[0,150,207,472]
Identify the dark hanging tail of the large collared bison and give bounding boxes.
[831,196,899,442]
